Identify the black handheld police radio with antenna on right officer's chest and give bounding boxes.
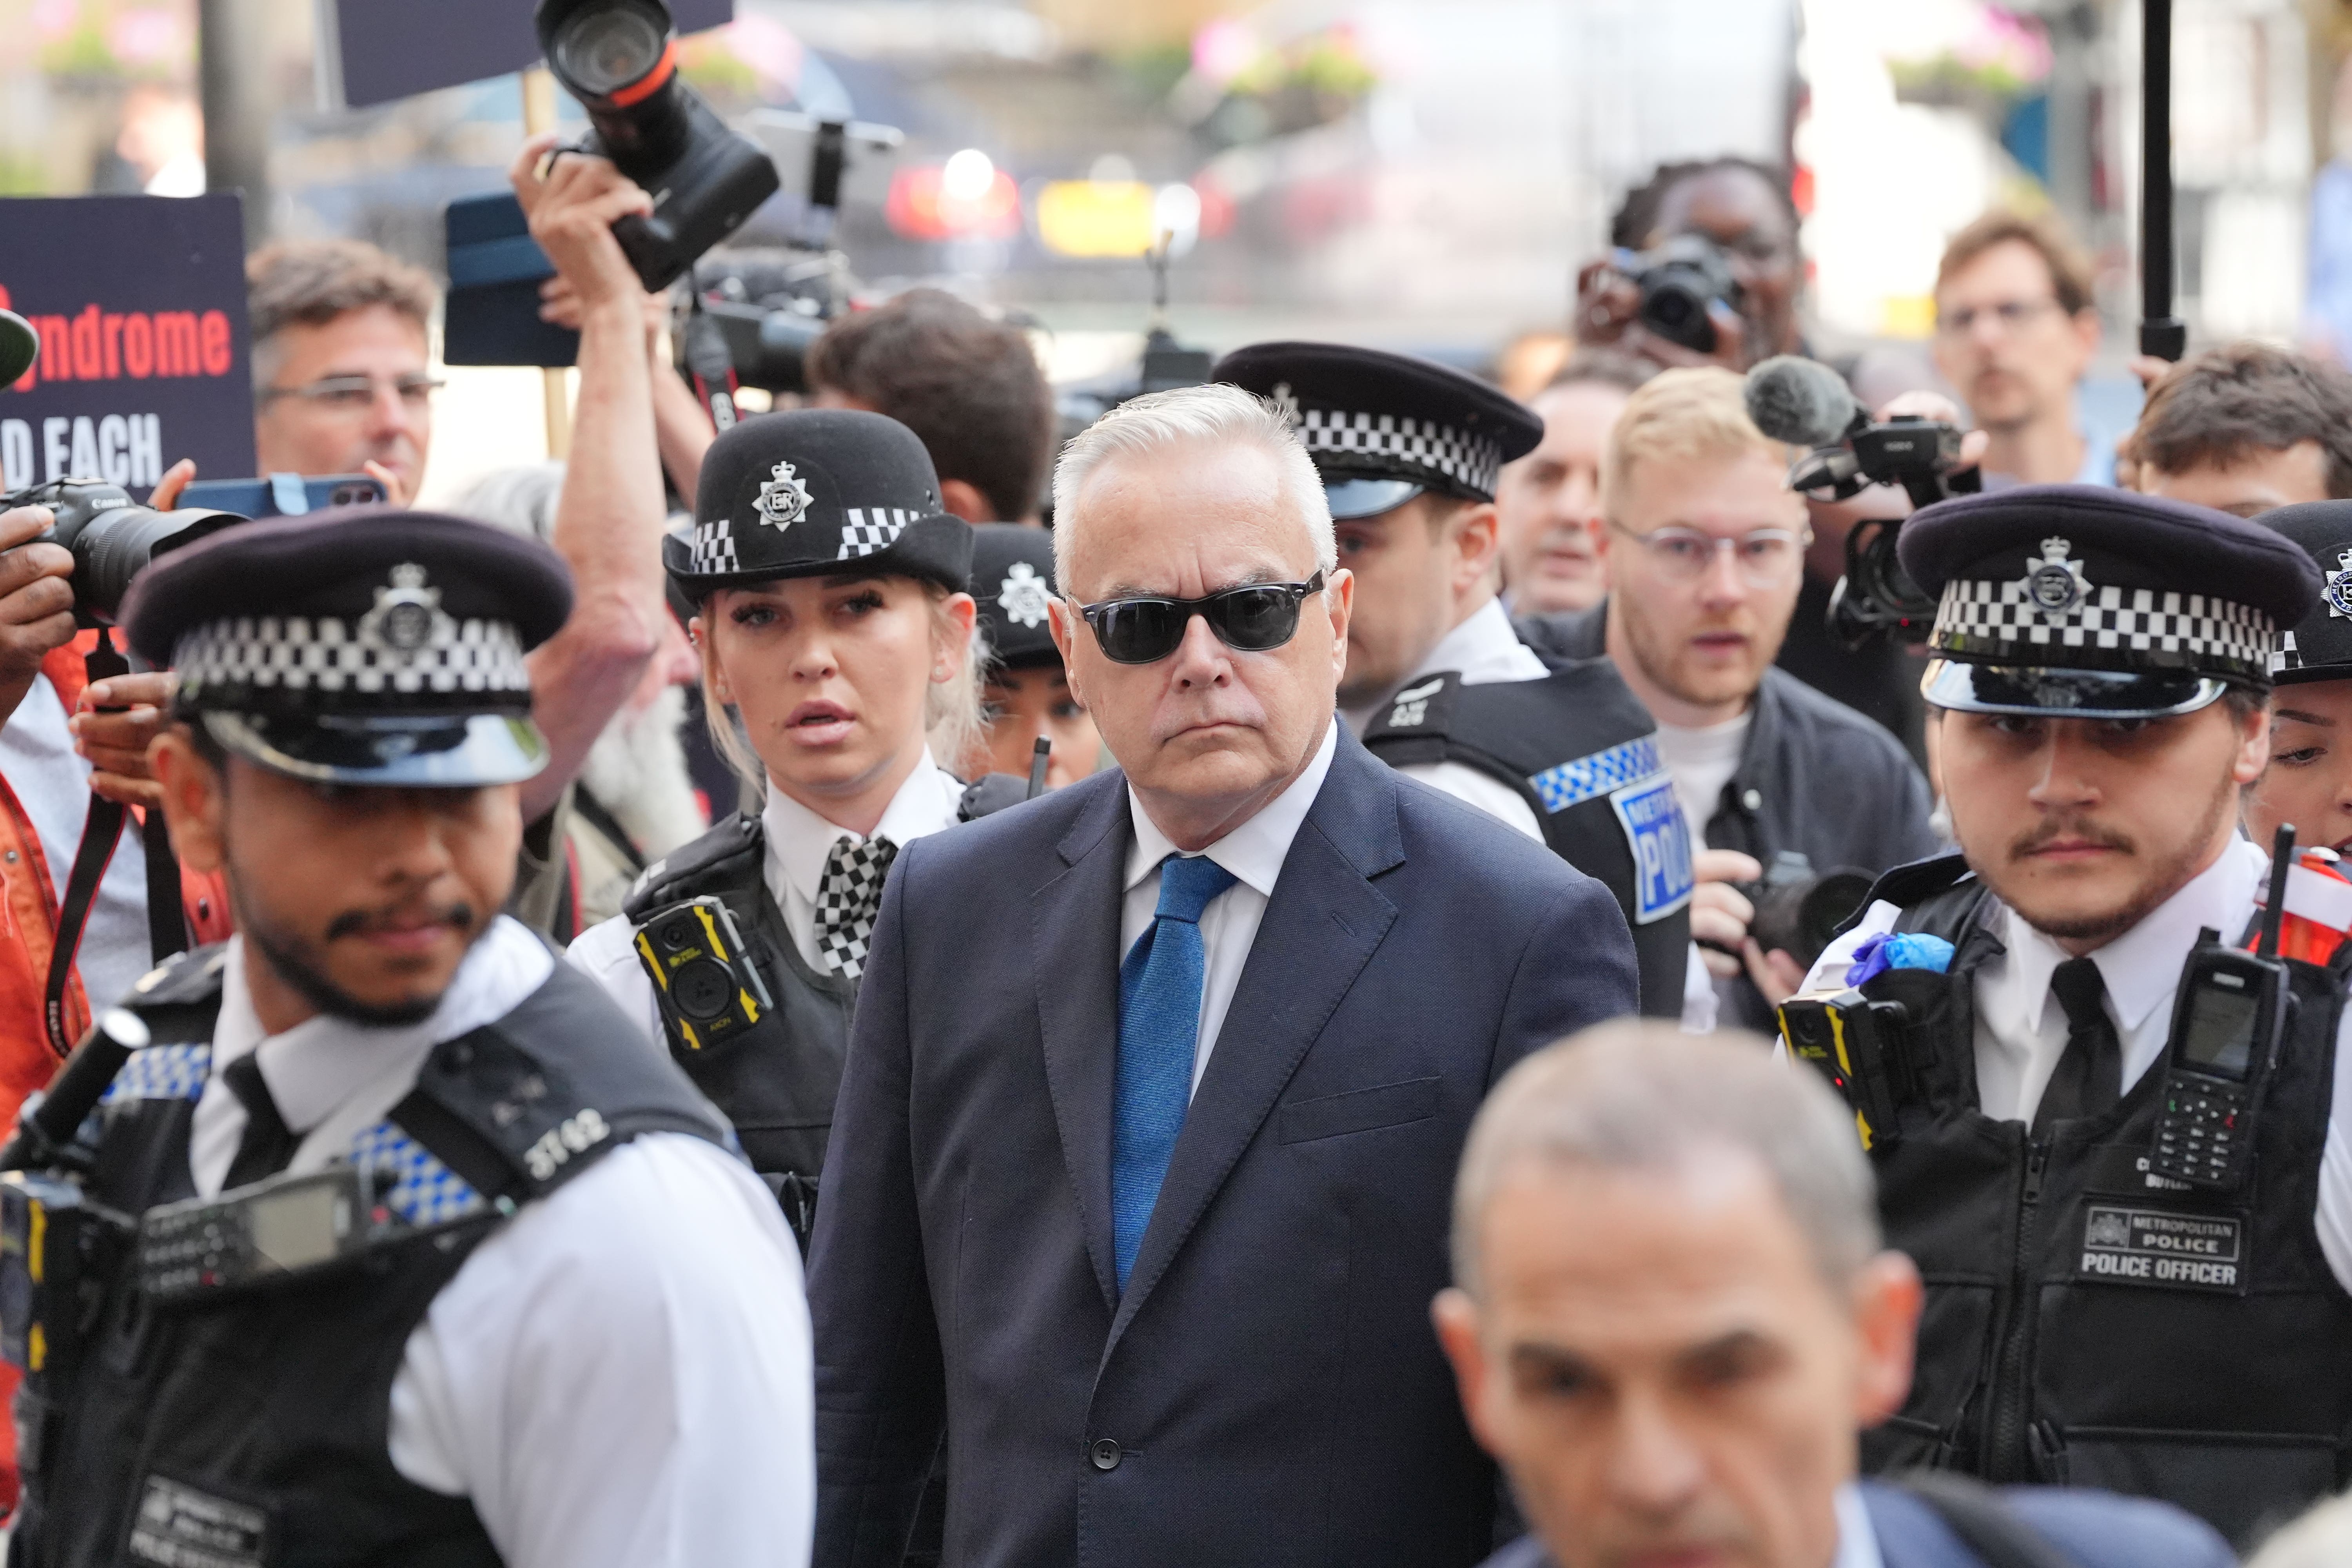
[2147,825,2296,1189]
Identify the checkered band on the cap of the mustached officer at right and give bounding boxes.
[1929,578,2277,677]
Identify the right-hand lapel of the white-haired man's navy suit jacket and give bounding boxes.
[1103,729,1404,1361]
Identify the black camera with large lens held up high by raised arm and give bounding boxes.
[536,0,781,292]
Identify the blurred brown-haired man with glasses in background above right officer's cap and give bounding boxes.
[1936,212,2114,484]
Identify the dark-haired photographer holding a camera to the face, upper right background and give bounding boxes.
[1576,158,1804,372]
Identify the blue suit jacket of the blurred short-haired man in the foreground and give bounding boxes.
[1486,1481,2237,1568]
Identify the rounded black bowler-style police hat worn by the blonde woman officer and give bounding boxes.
[661,409,971,602]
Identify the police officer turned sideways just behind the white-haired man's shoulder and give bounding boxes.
[1216,343,1712,1018]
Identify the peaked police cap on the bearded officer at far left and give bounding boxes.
[122,505,572,788]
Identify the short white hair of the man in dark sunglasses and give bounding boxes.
[1054,383,1338,592]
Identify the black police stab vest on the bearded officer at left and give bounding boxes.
[9,947,727,1568]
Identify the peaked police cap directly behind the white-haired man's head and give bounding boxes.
[1211,343,1543,517]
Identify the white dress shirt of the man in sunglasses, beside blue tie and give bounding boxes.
[1120,724,1338,1091]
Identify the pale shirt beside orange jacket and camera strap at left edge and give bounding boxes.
[0,675,153,1013]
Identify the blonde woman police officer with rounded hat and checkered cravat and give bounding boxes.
[569,409,1023,1241]
